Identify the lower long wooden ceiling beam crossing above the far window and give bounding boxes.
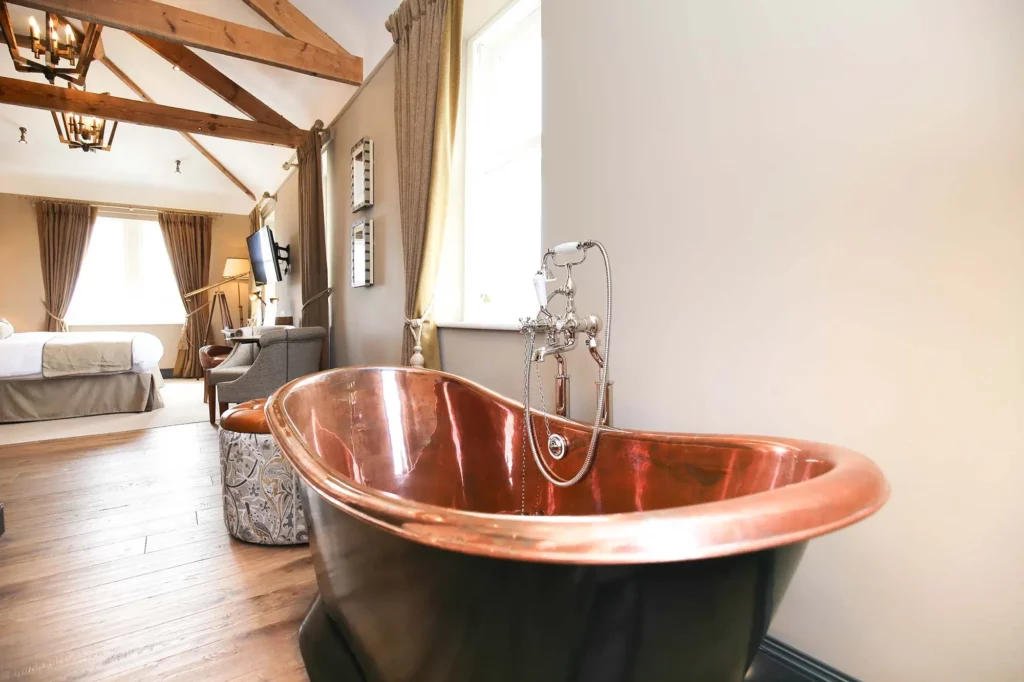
[0,77,303,148]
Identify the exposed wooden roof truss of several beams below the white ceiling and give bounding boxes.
[0,0,362,198]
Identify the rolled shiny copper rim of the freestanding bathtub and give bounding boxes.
[266,366,890,564]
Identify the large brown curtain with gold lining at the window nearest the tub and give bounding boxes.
[385,0,463,369]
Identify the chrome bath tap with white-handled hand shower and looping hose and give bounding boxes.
[519,241,611,487]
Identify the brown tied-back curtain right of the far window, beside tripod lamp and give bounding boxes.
[158,211,213,378]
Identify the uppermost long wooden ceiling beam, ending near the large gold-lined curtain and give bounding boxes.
[18,0,362,85]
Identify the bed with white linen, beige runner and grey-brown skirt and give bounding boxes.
[0,332,164,423]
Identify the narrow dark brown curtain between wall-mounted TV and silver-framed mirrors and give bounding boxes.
[298,121,331,369]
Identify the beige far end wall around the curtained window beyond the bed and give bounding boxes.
[0,194,249,369]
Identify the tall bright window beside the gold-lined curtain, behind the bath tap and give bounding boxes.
[463,0,542,324]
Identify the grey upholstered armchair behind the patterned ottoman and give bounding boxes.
[207,327,327,413]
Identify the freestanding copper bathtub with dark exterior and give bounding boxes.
[267,368,888,682]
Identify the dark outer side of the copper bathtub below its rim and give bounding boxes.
[300,485,806,682]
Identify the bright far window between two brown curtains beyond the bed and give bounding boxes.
[65,217,185,326]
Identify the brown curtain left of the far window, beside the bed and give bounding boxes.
[36,201,96,332]
